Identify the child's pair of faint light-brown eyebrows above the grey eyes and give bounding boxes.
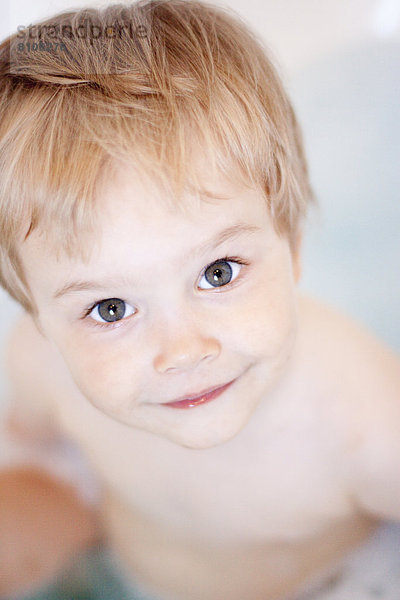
[53,223,261,300]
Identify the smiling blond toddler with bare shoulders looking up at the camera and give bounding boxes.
[0,0,400,600]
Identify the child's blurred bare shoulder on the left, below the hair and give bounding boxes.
[5,313,63,436]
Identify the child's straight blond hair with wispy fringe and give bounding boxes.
[0,0,312,312]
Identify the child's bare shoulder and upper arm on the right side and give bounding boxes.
[298,294,400,519]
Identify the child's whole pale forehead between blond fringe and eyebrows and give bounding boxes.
[22,164,270,278]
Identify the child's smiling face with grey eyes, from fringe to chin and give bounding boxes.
[21,164,297,448]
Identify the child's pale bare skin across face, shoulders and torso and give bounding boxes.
[2,163,400,600]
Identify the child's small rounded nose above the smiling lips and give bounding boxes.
[153,324,221,373]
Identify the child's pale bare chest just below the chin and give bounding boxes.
[60,390,352,542]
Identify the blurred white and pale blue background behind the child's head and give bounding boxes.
[0,0,400,410]
